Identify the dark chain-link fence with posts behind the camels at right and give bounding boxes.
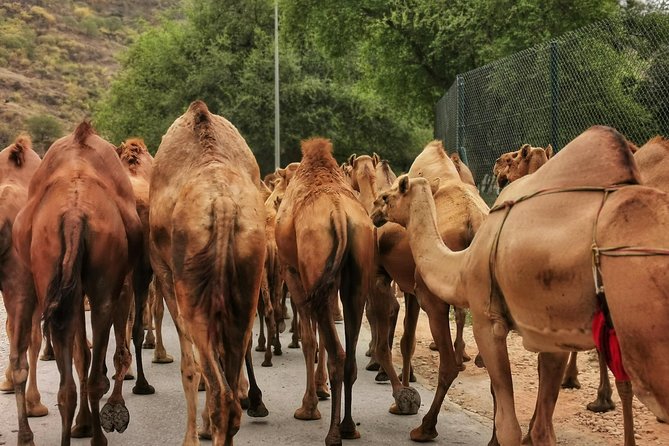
[435,11,669,201]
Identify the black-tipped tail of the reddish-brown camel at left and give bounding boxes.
[42,213,87,330]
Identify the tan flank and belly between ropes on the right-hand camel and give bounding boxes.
[494,193,601,352]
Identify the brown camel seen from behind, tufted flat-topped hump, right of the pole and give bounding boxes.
[276,138,374,445]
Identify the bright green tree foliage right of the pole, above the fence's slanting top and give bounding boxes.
[282,0,620,123]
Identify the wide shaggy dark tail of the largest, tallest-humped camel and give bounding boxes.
[184,197,236,339]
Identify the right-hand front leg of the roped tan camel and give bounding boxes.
[523,353,569,446]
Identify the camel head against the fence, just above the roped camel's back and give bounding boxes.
[492,144,553,189]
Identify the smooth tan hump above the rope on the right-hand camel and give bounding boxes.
[496,126,641,203]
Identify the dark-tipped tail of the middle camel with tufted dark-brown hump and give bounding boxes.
[306,211,348,316]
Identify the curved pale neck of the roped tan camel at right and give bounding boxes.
[407,185,468,306]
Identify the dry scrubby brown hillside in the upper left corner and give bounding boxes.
[0,0,179,152]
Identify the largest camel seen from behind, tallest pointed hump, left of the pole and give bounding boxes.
[149,101,268,445]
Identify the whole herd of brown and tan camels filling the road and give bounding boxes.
[0,101,669,446]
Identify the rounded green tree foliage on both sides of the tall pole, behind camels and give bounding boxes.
[94,0,427,172]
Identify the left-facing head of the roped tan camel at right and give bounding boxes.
[370,174,440,227]
